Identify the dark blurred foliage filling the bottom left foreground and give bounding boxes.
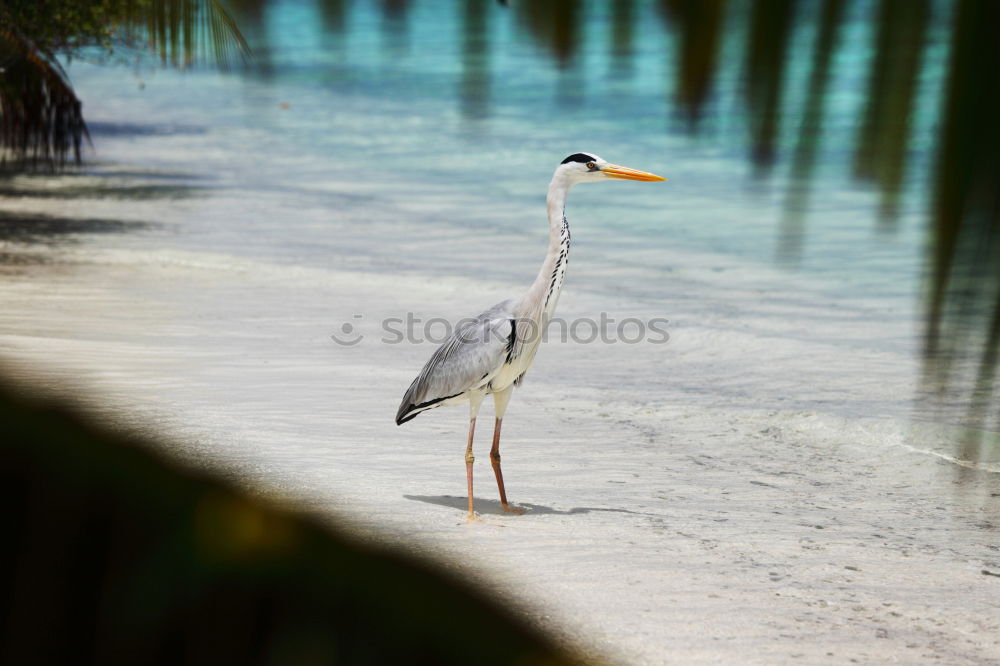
[0,384,580,666]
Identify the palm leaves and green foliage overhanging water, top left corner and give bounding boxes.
[0,0,250,169]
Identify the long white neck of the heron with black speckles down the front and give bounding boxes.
[518,171,573,323]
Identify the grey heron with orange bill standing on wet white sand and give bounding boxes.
[396,153,666,520]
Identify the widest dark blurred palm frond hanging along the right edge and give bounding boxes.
[924,0,1000,423]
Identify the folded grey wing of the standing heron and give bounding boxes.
[396,301,514,425]
